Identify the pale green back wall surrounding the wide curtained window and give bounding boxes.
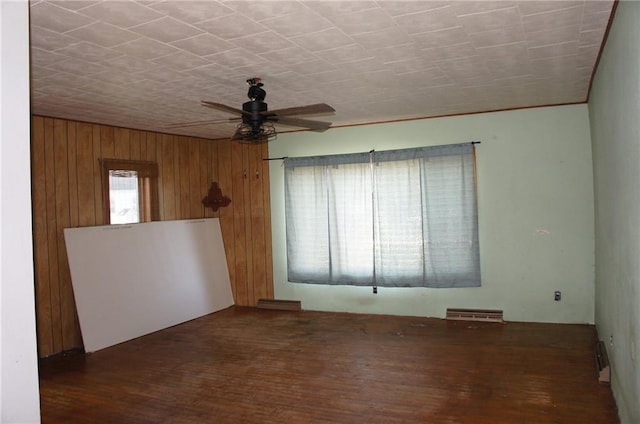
[269,105,594,323]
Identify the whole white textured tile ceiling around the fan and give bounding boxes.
[30,0,613,138]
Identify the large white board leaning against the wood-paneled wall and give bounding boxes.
[64,218,234,352]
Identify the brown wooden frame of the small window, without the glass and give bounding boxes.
[100,159,160,225]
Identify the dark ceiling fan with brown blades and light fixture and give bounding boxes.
[168,77,335,144]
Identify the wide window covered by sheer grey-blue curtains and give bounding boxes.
[285,143,480,287]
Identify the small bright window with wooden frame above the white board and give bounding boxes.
[102,159,159,224]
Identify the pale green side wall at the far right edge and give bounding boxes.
[589,1,640,423]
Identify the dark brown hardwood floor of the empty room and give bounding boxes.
[40,307,618,424]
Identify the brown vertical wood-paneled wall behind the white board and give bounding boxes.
[31,116,273,357]
